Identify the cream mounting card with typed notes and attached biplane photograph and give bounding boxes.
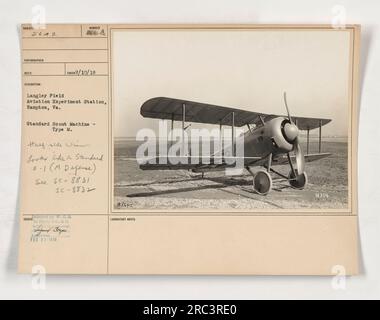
[19,24,360,275]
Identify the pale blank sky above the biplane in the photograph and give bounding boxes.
[112,29,350,137]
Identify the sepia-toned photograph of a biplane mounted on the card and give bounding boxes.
[112,27,353,211]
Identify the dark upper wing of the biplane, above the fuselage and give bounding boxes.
[140,97,331,130]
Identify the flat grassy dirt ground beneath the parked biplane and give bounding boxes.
[114,141,348,211]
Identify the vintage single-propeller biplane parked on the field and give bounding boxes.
[140,93,331,195]
